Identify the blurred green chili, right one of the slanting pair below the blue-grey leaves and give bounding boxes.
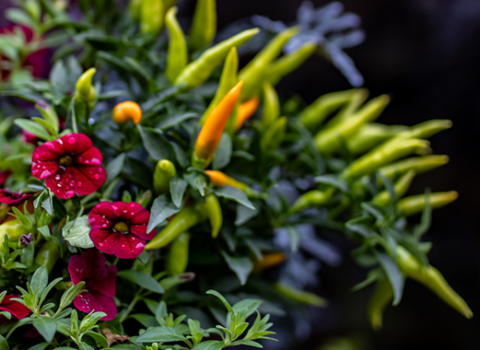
[265,43,317,86]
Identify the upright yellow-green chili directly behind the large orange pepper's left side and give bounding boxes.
[200,47,238,126]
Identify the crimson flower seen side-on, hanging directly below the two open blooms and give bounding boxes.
[68,249,117,321]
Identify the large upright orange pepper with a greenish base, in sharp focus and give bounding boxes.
[192,81,243,168]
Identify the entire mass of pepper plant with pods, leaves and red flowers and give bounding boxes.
[0,0,472,350]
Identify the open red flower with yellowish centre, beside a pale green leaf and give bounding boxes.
[88,202,155,259]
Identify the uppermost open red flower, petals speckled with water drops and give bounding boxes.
[32,133,106,199]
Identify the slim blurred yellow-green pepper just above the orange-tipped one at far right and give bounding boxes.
[379,155,448,181]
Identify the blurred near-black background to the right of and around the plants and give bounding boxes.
[0,0,480,350]
